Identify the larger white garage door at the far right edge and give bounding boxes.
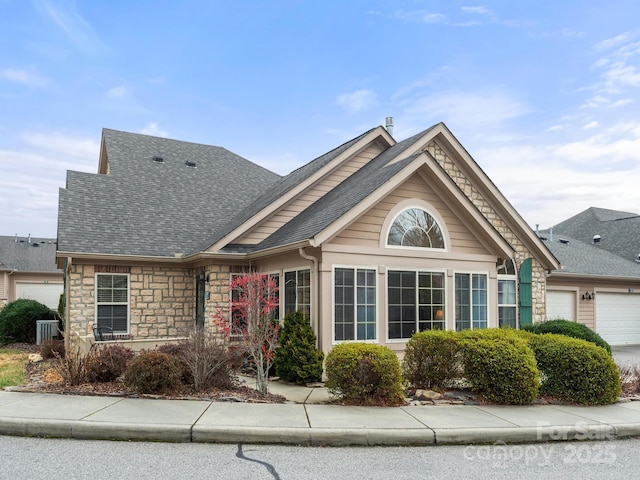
[594,292,640,345]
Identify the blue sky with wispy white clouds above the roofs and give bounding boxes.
[0,0,640,237]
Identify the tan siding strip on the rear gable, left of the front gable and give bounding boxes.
[237,144,382,244]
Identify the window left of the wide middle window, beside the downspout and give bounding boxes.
[334,268,376,341]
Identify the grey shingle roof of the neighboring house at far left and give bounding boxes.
[0,236,61,272]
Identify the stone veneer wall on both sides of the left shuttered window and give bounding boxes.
[68,264,195,339]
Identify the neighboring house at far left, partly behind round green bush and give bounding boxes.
[0,235,63,310]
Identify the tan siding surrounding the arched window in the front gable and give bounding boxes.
[332,175,487,254]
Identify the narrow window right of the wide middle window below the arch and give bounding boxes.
[456,273,488,331]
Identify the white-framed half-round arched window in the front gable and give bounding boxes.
[387,207,445,248]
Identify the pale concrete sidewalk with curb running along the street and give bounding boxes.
[0,382,640,446]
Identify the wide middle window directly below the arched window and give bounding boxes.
[387,270,445,339]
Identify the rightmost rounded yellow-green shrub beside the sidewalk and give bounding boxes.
[529,333,621,405]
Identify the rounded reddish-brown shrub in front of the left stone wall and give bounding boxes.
[124,350,182,393]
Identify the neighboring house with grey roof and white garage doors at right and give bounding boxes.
[539,207,640,345]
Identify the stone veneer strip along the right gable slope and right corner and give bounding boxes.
[425,141,546,323]
